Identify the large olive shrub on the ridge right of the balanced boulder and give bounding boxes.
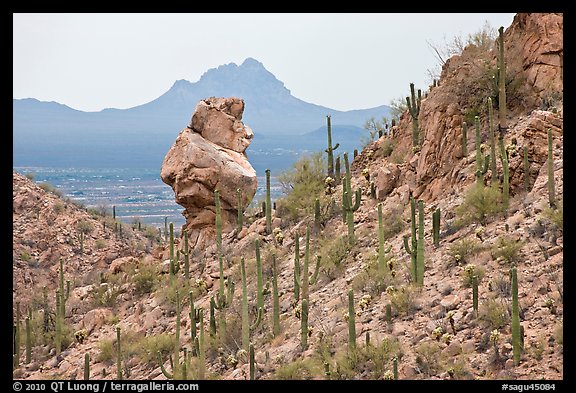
[276,153,329,221]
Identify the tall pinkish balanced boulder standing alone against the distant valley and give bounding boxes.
[160,97,258,246]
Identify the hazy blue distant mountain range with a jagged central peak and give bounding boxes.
[13,58,390,174]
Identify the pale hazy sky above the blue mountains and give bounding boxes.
[13,13,514,111]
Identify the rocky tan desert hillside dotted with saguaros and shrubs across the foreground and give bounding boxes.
[13,14,564,379]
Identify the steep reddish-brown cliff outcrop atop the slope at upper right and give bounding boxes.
[353,14,563,202]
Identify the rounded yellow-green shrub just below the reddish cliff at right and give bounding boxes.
[456,183,504,226]
